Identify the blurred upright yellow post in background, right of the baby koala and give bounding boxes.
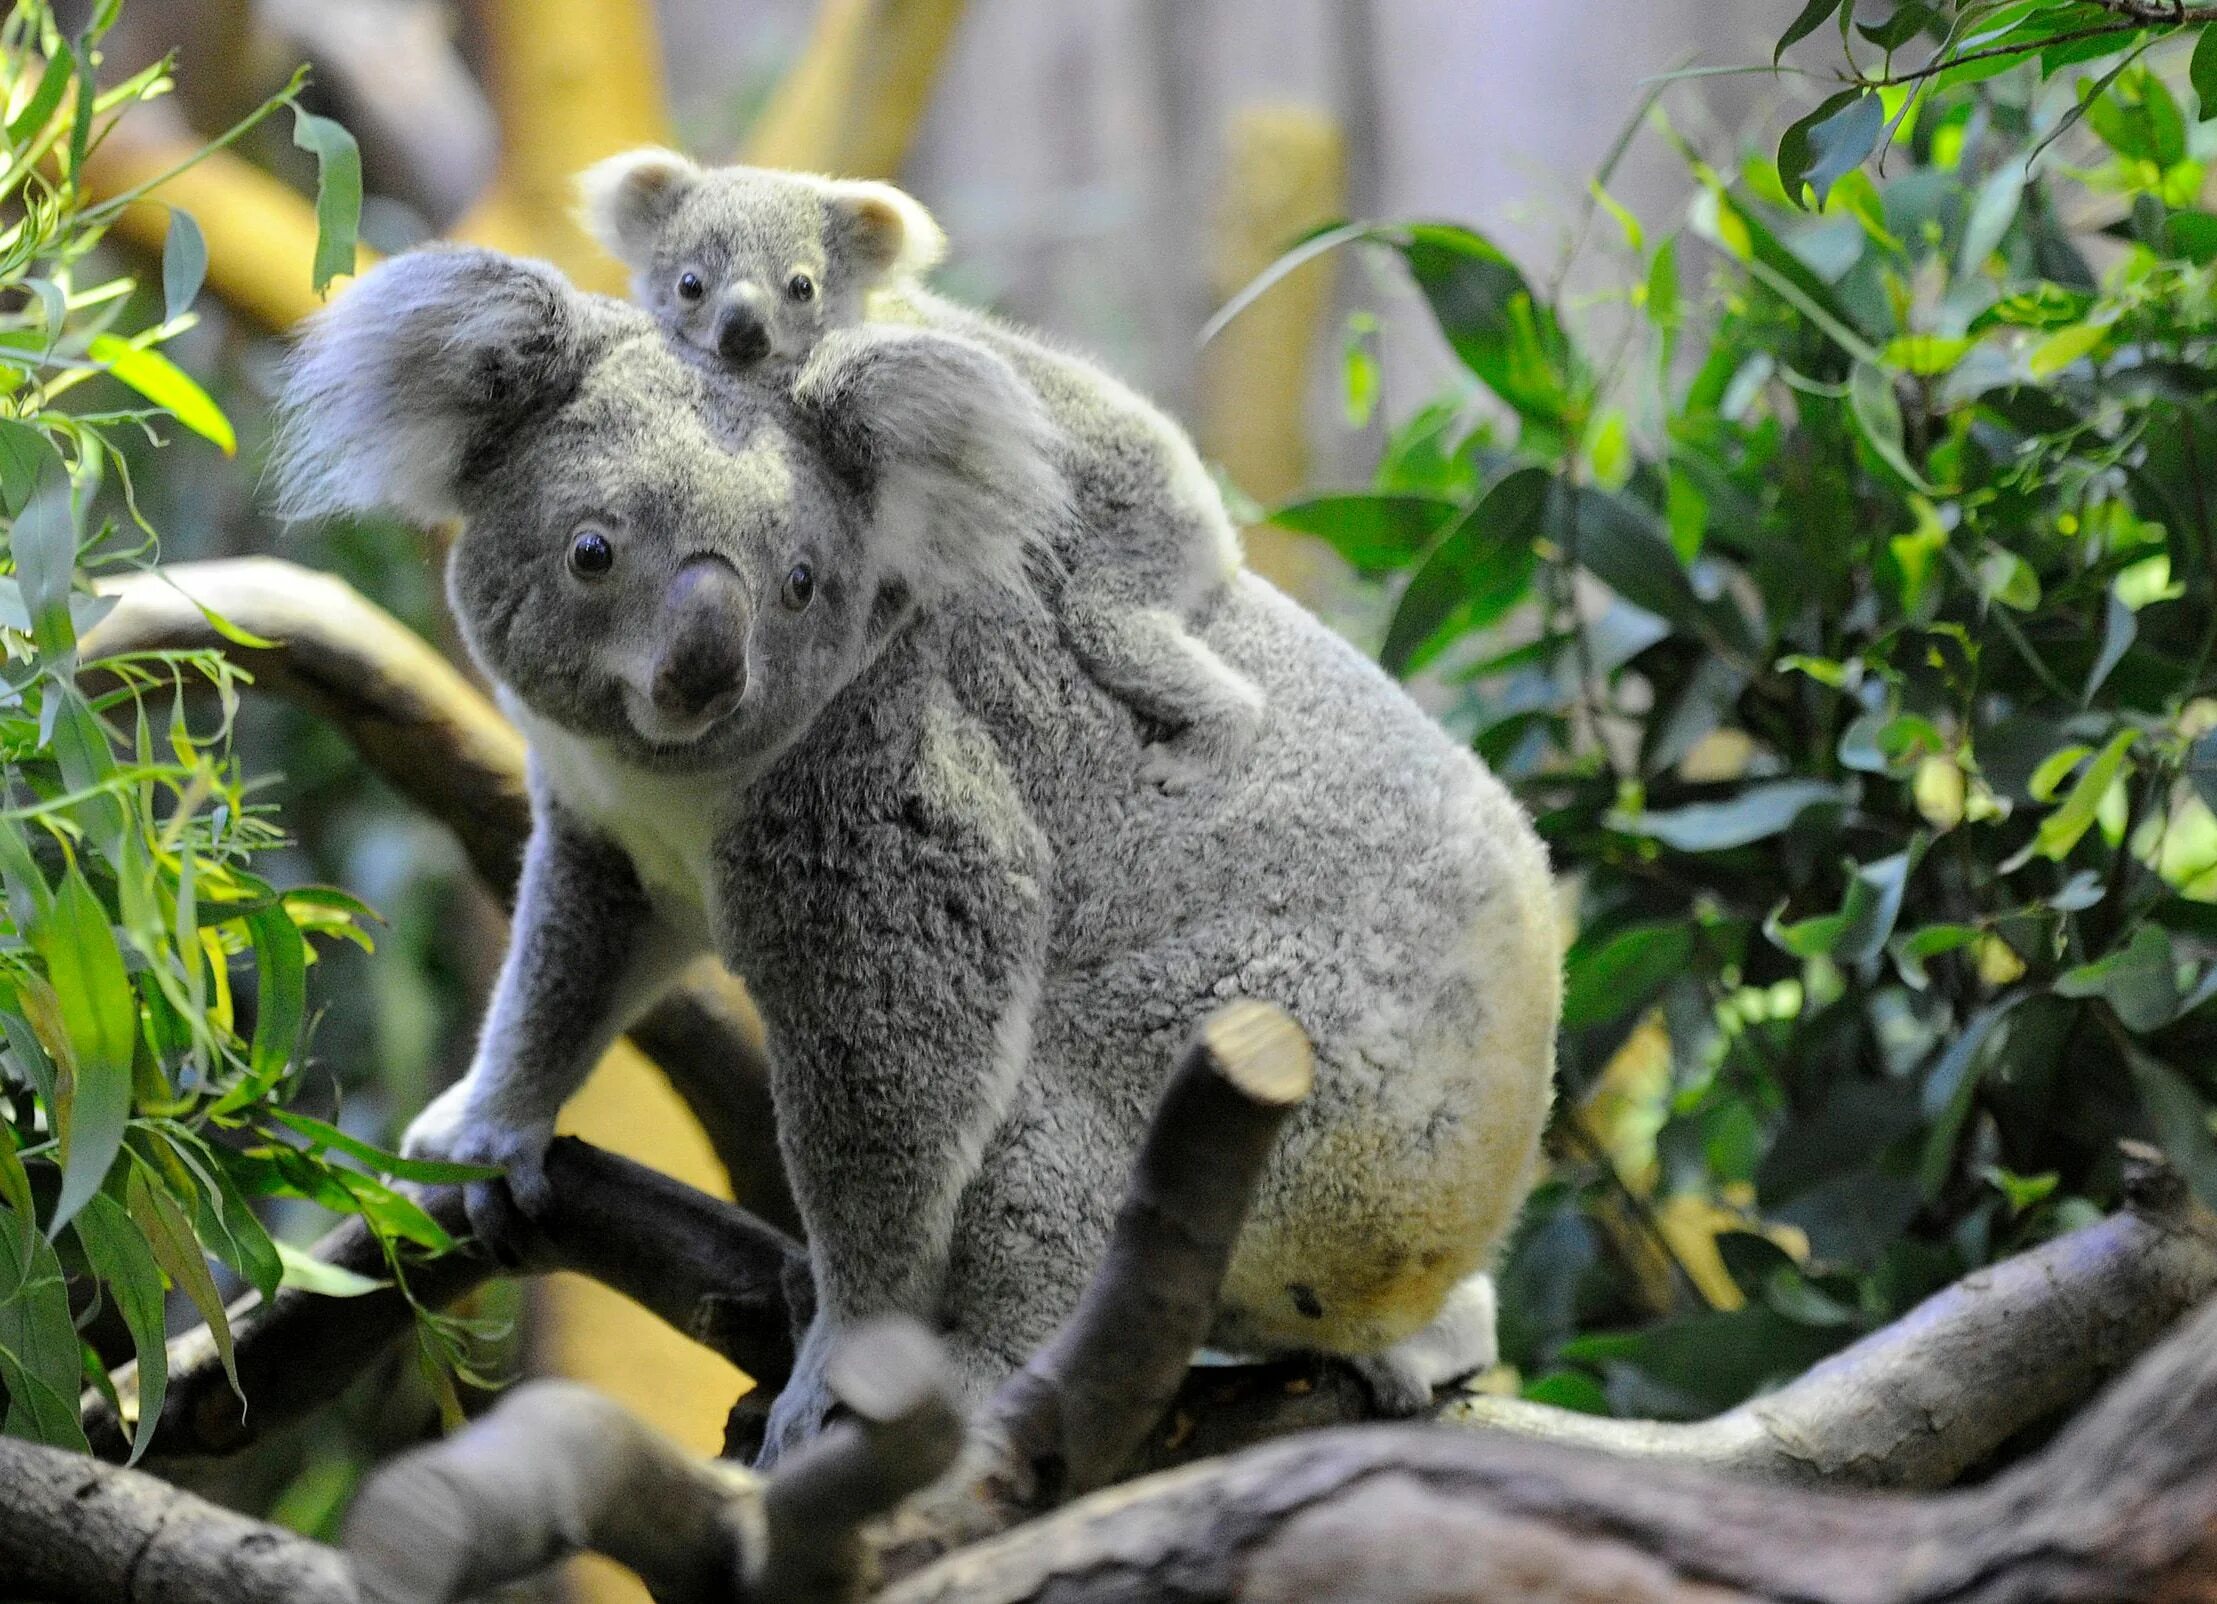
[1202,102,1348,598]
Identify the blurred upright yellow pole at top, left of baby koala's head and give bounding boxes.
[454,0,670,290]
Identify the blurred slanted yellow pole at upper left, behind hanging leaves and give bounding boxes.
[84,115,377,328]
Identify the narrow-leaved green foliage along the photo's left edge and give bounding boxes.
[0,0,481,1453]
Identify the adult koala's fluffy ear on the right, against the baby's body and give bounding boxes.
[794,323,1071,605]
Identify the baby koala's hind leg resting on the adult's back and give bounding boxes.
[1062,580,1261,791]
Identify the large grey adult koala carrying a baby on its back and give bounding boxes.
[282,250,1559,1456]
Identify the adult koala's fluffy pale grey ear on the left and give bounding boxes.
[273,246,588,523]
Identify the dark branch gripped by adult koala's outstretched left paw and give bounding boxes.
[84,1139,807,1458]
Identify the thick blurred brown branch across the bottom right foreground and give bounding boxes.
[880,1305,2217,1604]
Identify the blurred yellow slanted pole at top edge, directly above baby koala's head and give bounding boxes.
[740,0,962,177]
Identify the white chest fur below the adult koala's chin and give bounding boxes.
[501,696,738,919]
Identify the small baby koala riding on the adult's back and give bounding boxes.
[579,148,1261,791]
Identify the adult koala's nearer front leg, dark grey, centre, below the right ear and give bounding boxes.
[725,717,1046,1462]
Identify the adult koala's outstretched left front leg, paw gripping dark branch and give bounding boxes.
[401,804,701,1243]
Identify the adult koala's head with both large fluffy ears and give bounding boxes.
[277,248,1064,769]
